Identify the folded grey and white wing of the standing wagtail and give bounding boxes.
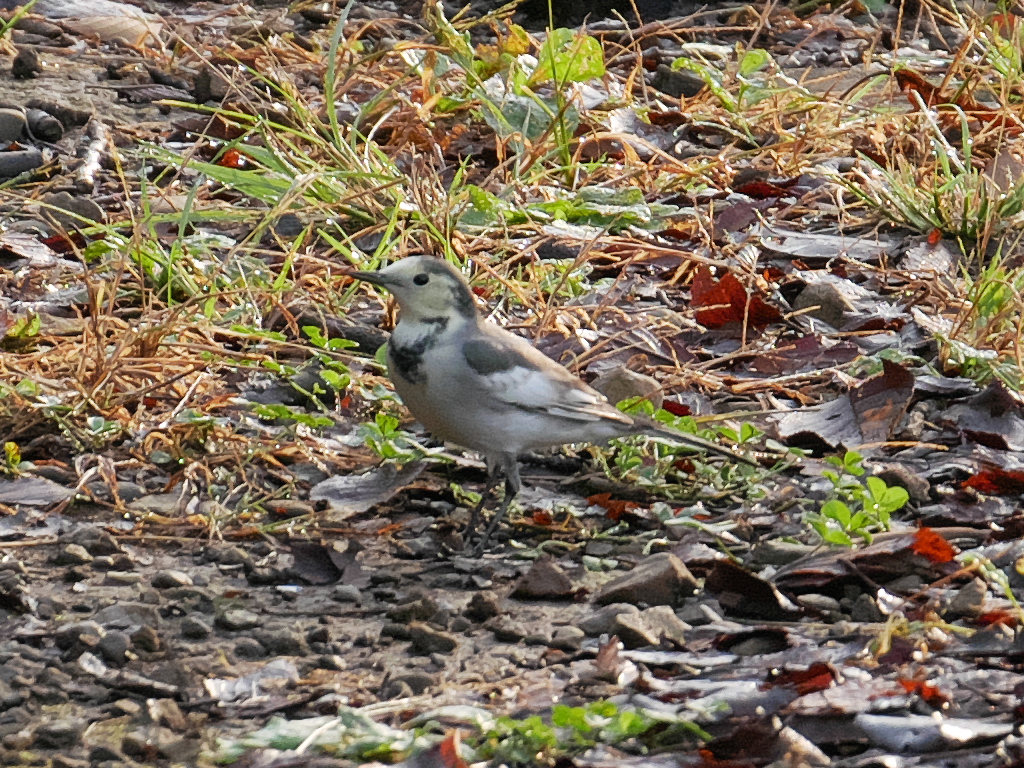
[462,331,633,426]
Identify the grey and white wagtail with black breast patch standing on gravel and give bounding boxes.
[348,256,757,554]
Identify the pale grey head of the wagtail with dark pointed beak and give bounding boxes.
[349,256,476,323]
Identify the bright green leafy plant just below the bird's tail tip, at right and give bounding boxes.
[807,451,910,547]
